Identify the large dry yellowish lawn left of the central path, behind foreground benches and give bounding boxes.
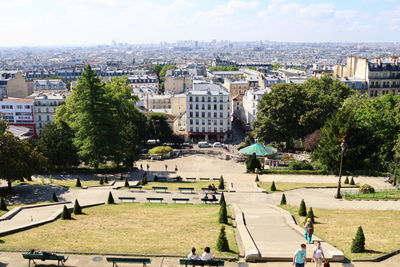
[0,203,238,257]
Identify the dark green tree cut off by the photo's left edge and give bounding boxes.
[0,132,47,190]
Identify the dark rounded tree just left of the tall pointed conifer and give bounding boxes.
[37,120,79,168]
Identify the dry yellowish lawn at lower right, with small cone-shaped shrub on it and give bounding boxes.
[280,205,400,259]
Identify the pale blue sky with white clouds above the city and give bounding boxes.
[0,0,400,46]
